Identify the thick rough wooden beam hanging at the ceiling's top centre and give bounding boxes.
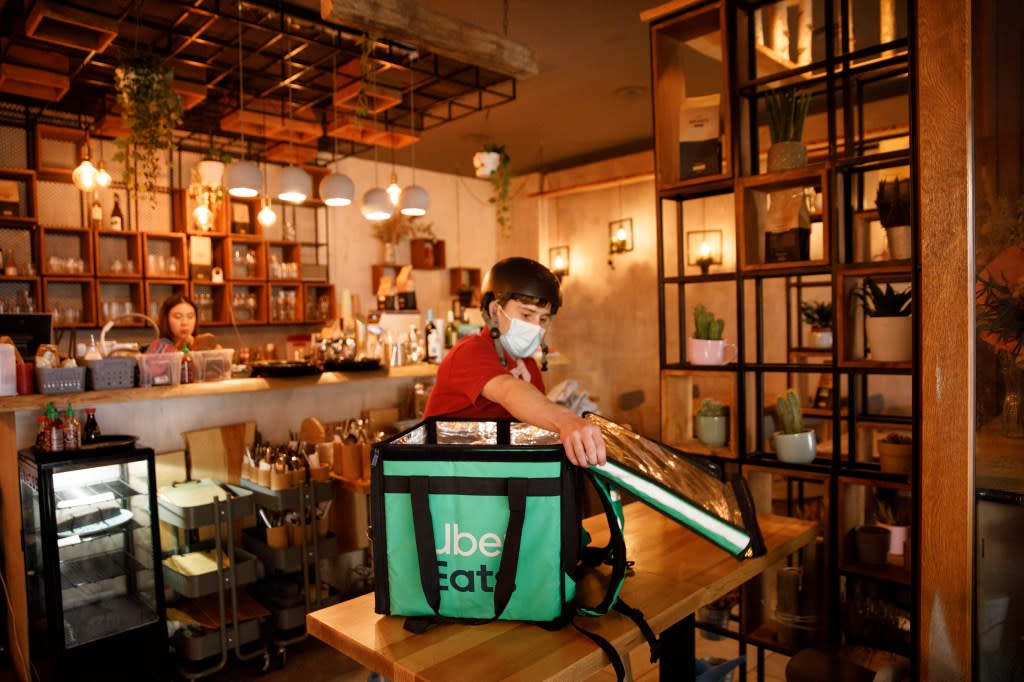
[321,0,538,79]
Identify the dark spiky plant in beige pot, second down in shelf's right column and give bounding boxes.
[853,278,913,363]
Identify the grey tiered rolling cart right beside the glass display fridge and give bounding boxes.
[158,479,270,679]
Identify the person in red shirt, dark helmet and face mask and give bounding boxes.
[424,257,605,466]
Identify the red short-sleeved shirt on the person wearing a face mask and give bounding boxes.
[424,329,545,419]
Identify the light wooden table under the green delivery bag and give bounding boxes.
[306,502,817,682]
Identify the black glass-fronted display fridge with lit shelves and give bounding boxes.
[18,436,167,680]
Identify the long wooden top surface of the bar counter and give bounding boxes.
[0,364,437,414]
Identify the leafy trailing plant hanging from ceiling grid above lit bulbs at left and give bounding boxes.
[114,54,184,199]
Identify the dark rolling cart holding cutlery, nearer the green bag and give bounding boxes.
[242,478,338,666]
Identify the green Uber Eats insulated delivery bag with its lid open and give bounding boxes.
[371,414,765,660]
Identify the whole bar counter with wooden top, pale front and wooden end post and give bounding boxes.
[0,365,437,680]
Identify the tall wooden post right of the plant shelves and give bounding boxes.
[914,0,974,680]
